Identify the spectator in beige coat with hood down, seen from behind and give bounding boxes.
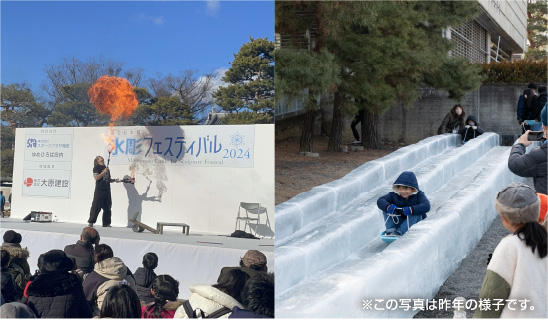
[83,244,136,316]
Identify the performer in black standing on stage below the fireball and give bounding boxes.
[88,156,118,227]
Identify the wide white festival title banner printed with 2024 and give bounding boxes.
[105,125,255,168]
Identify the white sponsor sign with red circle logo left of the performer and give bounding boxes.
[21,128,73,198]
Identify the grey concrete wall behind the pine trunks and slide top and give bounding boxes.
[276,84,541,145]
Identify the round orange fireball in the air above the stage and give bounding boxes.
[88,75,139,125]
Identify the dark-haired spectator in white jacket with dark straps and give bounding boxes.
[173,269,249,319]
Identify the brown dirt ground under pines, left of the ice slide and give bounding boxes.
[275,136,404,205]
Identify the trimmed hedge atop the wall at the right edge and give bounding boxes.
[481,59,548,84]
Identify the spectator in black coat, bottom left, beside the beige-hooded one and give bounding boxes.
[27,250,92,318]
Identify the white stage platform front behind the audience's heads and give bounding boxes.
[0,218,274,298]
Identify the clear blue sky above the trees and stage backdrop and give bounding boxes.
[0,0,274,94]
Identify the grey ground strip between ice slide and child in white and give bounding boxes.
[414,179,533,318]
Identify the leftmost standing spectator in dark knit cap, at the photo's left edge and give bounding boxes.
[0,230,31,299]
